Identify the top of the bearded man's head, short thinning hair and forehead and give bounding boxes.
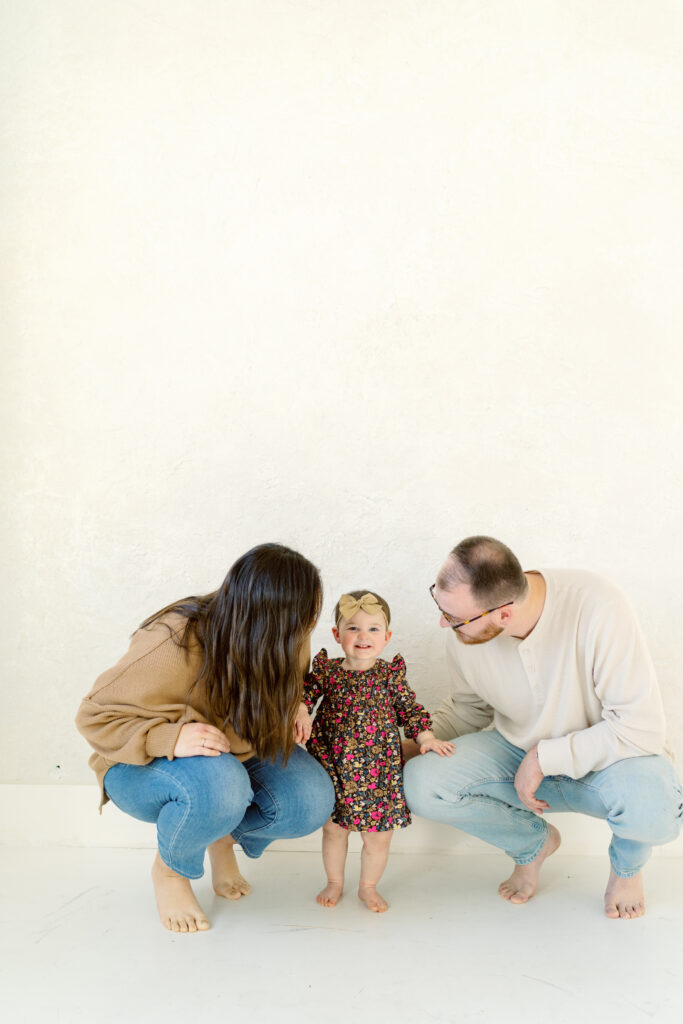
[436,537,528,608]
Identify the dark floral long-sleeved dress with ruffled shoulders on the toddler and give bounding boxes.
[303,650,431,831]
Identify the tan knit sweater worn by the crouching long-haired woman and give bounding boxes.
[76,614,254,808]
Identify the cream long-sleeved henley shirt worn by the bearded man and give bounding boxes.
[433,569,669,778]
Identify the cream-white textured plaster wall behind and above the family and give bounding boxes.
[0,0,683,783]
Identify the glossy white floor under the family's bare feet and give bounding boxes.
[5,846,683,1024]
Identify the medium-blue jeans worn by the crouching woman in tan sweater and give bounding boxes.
[104,746,335,879]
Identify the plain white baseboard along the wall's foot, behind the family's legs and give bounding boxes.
[0,785,683,857]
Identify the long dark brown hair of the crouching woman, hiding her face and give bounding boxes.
[140,544,323,762]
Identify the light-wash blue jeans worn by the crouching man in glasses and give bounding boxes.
[403,731,683,879]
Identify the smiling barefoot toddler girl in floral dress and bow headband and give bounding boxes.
[304,590,455,913]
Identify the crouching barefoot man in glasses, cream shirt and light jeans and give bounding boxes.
[404,537,683,919]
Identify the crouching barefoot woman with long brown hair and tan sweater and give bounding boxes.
[76,544,334,932]
